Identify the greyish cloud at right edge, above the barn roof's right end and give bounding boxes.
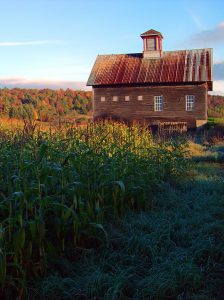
[190,22,224,46]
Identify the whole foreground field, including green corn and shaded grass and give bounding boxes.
[0,123,224,299]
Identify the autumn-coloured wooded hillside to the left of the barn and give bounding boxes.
[0,88,92,122]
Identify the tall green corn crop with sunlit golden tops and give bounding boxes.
[0,123,187,299]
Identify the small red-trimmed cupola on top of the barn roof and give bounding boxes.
[141,29,163,59]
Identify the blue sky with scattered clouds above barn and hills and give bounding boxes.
[0,0,224,94]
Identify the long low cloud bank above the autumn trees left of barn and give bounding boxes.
[0,77,91,91]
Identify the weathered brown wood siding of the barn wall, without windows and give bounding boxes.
[93,84,207,126]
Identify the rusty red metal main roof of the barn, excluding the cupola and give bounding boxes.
[87,49,212,88]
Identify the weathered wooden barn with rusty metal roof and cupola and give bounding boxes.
[87,29,213,128]
